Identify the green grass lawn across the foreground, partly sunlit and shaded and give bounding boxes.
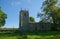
[0,31,60,39]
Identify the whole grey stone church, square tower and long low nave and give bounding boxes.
[19,10,52,31]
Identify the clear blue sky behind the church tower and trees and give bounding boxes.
[0,0,44,28]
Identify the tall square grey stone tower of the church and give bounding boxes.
[19,10,29,31]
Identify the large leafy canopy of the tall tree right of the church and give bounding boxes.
[37,0,60,28]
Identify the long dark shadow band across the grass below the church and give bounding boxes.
[0,31,60,36]
